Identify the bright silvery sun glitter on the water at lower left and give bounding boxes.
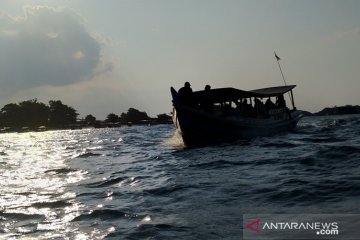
[0,131,86,238]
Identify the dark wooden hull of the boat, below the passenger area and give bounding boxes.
[173,105,302,147]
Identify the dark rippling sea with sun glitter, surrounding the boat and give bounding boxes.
[0,115,360,239]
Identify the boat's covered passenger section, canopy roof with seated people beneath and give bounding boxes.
[184,85,296,120]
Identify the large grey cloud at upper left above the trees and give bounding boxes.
[0,6,105,91]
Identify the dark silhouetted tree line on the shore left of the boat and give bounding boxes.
[0,99,171,130]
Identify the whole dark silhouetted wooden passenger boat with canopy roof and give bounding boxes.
[170,85,303,147]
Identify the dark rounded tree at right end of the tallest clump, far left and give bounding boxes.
[49,100,78,127]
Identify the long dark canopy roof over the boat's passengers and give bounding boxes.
[194,85,296,103]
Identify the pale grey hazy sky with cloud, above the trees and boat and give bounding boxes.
[0,0,360,119]
